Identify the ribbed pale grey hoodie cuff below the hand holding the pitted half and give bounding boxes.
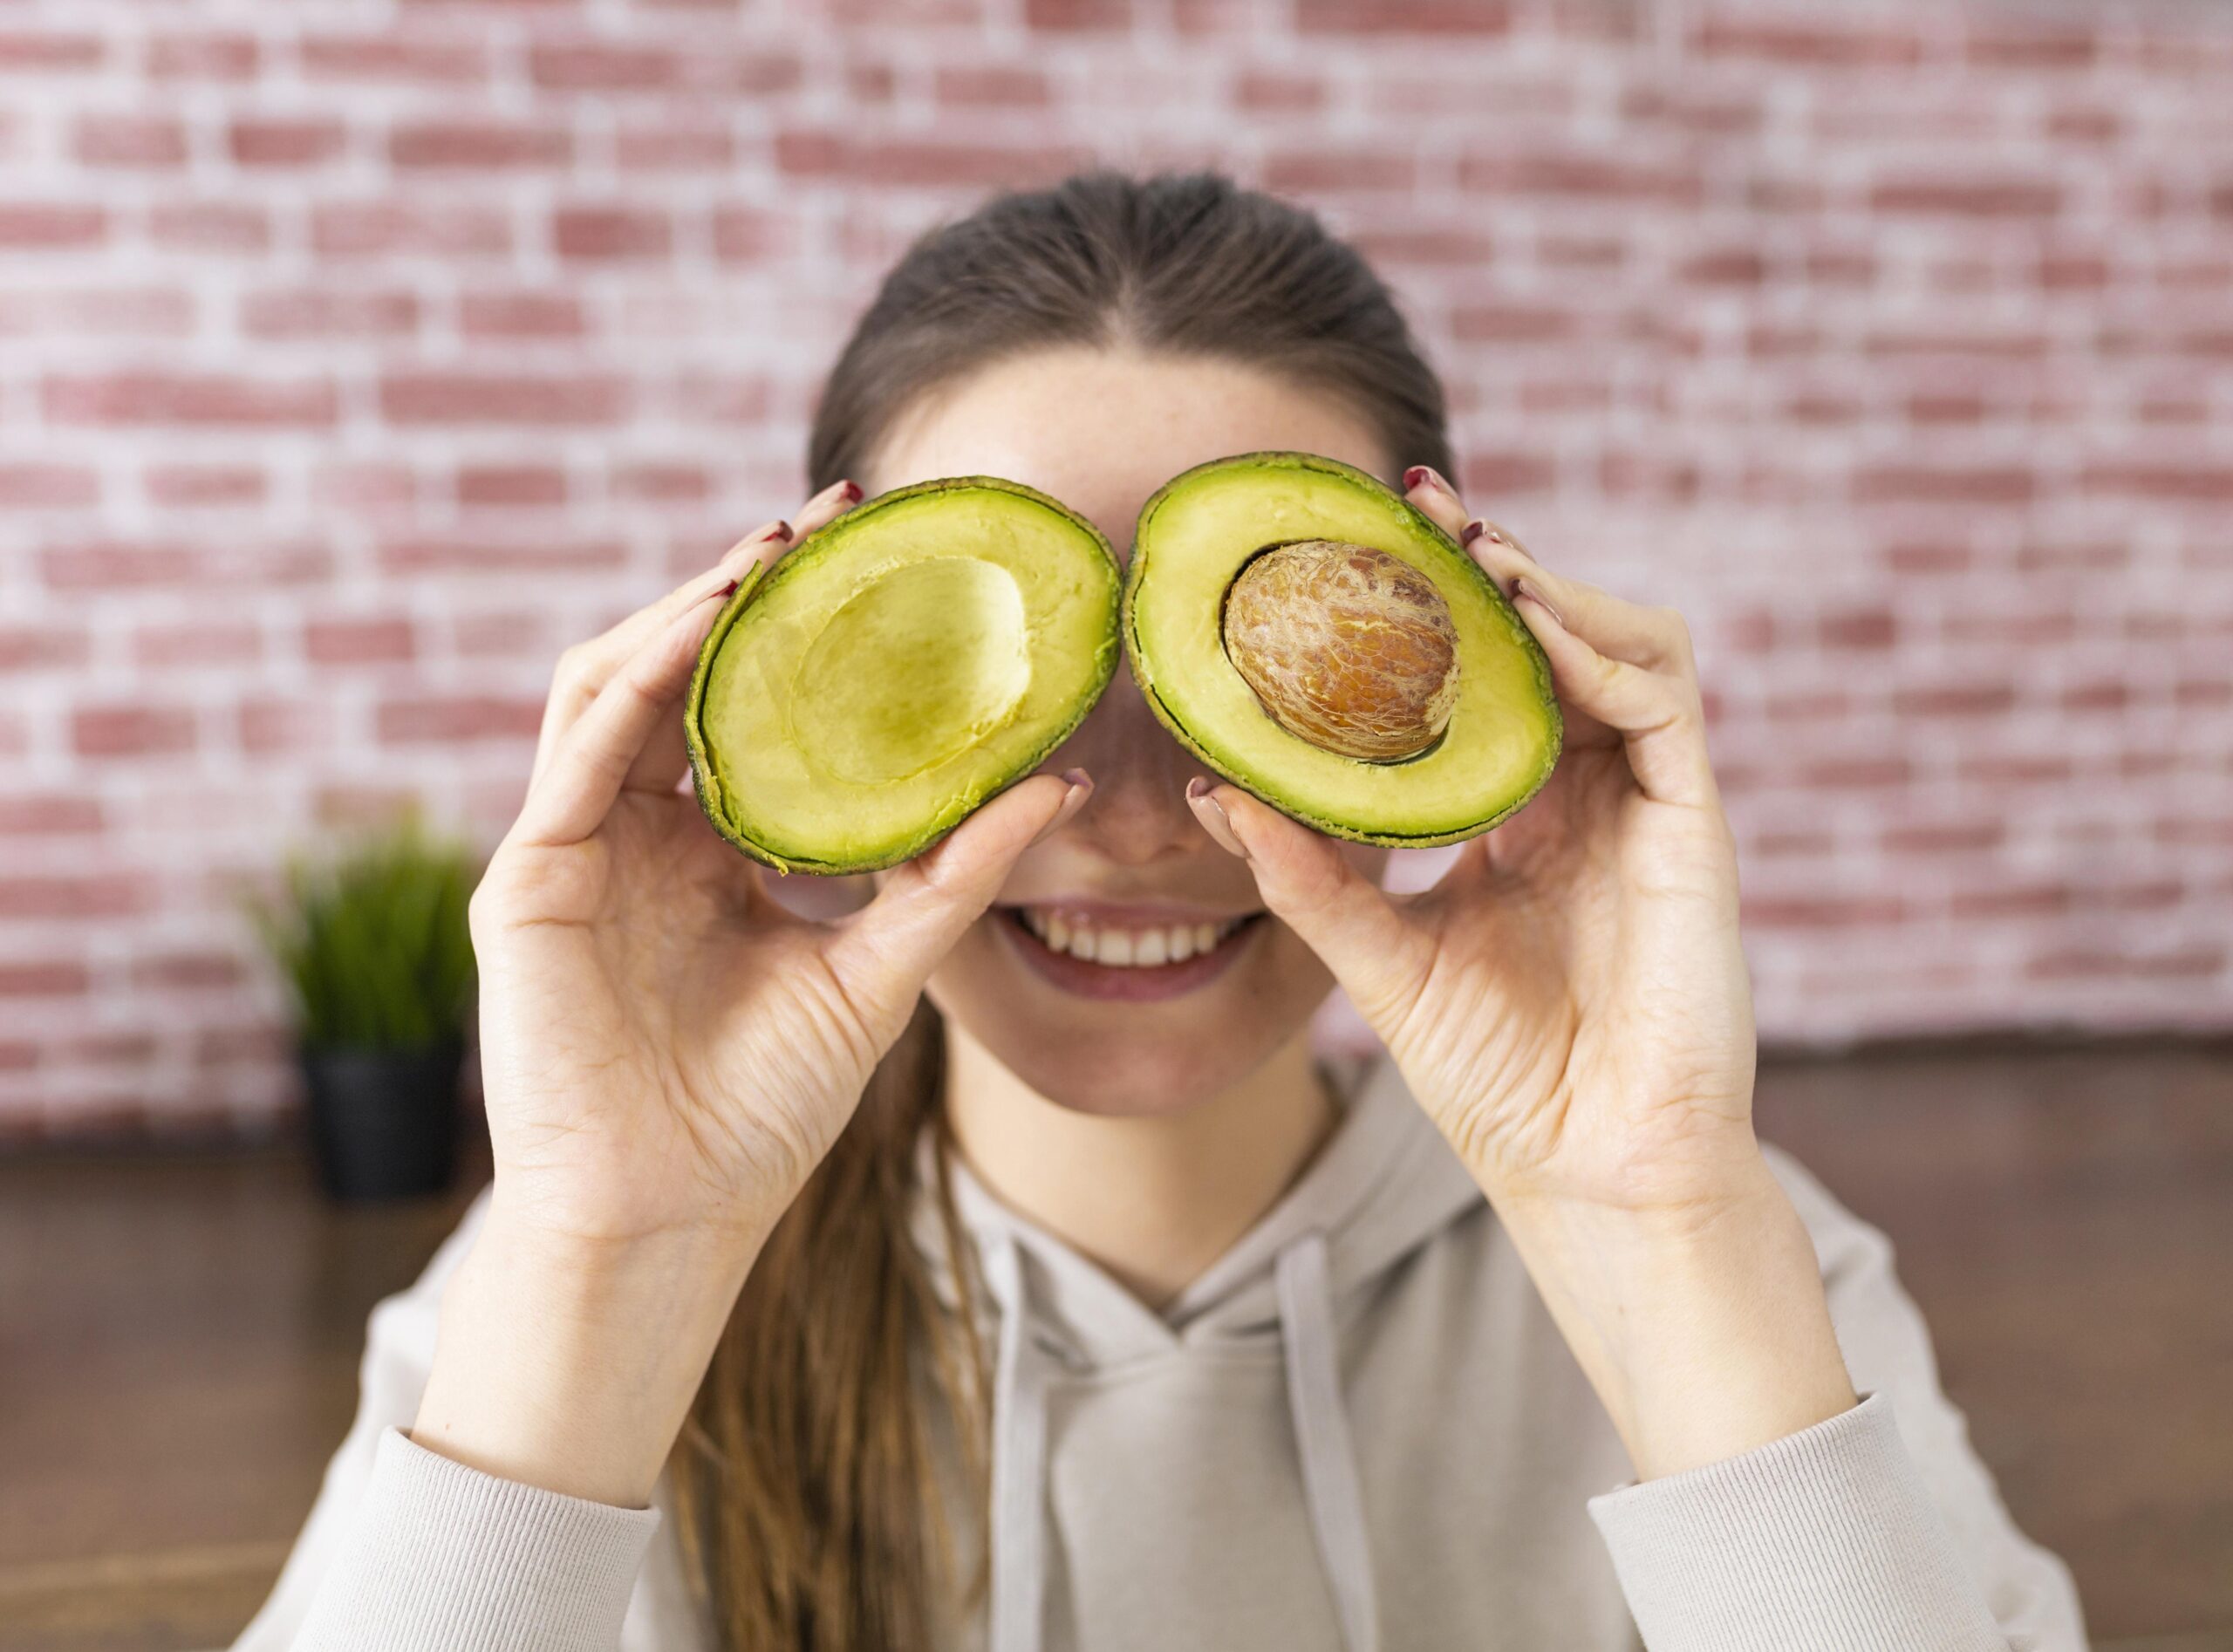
[1590,1396,2007,1652]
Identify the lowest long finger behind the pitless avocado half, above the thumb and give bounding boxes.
[511,585,734,849]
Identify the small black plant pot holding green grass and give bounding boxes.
[302,1041,464,1198]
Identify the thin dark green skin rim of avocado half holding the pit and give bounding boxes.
[1121,451,1566,849]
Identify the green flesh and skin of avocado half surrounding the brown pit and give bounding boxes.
[1123,454,1560,849]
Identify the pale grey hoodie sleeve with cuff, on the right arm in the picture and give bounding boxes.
[1590,1150,2086,1652]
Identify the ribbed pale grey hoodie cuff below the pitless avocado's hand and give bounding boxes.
[295,1429,659,1652]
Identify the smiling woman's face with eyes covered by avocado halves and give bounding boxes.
[857,348,1391,1114]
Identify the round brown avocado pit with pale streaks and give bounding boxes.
[1221,540,1458,763]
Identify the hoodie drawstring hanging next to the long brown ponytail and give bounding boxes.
[985,1232,1048,1652]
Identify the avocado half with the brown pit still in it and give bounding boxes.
[1123,454,1560,849]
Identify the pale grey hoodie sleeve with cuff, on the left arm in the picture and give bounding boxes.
[232,1194,659,1652]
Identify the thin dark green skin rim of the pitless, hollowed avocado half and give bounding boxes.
[683,475,1119,877]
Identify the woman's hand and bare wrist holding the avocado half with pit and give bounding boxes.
[1190,471,1854,1473]
